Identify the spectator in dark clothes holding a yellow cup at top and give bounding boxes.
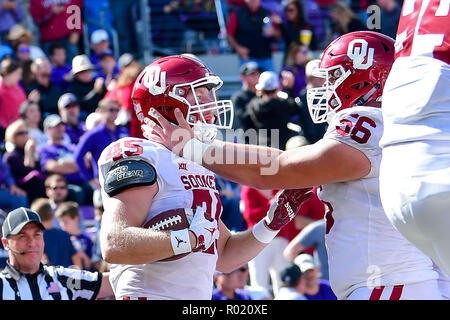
[280,0,317,56]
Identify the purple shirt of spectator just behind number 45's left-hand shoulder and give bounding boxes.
[74,123,130,181]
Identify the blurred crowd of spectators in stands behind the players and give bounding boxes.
[0,0,401,300]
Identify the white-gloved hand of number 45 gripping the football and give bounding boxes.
[189,207,219,252]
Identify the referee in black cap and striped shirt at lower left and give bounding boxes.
[0,207,114,300]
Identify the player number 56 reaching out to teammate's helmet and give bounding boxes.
[145,31,442,300]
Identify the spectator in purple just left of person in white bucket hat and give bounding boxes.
[50,42,72,92]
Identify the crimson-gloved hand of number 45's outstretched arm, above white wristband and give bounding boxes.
[264,188,313,230]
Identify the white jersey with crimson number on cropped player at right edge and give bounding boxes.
[380,0,450,147]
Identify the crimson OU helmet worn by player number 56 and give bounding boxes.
[307,31,395,123]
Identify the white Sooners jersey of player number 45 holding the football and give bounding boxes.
[99,138,222,300]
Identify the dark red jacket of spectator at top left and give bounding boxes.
[29,0,83,42]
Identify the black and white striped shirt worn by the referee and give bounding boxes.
[0,262,102,300]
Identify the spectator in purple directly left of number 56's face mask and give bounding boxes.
[281,42,309,97]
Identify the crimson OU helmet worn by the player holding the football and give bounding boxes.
[131,55,233,140]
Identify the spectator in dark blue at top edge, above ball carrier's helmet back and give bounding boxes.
[109,0,138,54]
